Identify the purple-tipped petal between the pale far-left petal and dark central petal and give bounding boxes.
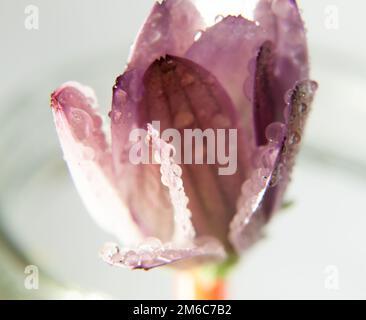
[110,70,173,241]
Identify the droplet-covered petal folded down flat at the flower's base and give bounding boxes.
[101,238,226,270]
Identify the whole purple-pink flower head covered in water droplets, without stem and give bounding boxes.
[51,0,317,269]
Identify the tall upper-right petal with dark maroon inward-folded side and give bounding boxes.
[249,0,309,145]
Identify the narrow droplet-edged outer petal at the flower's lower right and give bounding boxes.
[229,81,317,251]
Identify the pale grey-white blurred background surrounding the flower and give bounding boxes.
[0,0,366,299]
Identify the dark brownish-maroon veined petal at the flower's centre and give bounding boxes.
[139,56,248,249]
